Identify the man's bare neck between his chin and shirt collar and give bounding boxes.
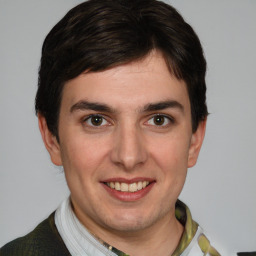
[81,210,184,256]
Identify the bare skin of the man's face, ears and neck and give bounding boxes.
[39,51,205,255]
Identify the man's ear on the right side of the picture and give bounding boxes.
[188,119,206,167]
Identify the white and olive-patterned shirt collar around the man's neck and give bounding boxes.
[55,198,199,256]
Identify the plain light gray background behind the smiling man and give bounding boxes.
[0,0,256,255]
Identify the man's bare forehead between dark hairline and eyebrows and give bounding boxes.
[62,52,189,111]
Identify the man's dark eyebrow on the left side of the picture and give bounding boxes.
[70,100,115,113]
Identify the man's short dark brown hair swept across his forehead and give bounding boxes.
[35,0,208,138]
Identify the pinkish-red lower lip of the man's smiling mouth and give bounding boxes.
[102,182,155,202]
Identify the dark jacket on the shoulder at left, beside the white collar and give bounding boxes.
[0,213,70,256]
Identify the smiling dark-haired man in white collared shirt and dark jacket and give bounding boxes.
[0,0,219,256]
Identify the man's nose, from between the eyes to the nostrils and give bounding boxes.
[111,121,148,171]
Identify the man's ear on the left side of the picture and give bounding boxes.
[38,113,62,166]
